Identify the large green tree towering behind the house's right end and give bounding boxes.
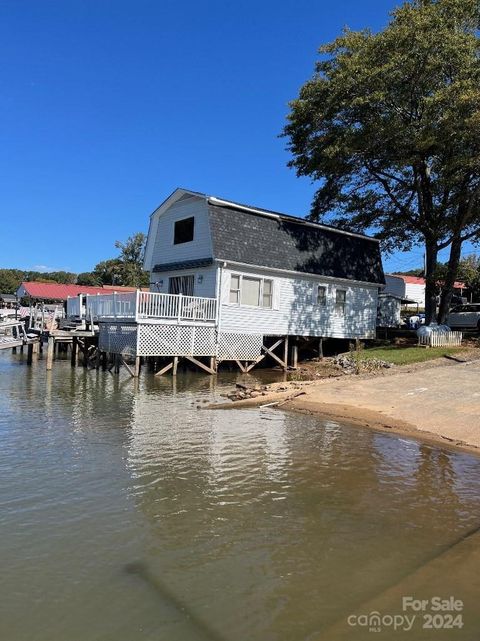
[284,0,480,321]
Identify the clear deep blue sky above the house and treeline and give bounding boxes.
[0,0,472,272]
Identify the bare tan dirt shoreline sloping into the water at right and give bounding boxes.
[209,355,480,456]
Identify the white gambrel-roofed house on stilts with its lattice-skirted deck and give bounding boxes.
[88,189,384,372]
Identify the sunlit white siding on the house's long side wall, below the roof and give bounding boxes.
[220,268,378,338]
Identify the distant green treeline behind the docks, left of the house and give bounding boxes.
[0,232,149,294]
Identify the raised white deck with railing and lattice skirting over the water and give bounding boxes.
[67,290,270,362]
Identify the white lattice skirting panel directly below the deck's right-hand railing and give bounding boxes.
[138,323,217,356]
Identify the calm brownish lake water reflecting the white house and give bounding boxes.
[0,352,480,641]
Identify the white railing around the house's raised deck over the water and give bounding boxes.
[67,290,217,323]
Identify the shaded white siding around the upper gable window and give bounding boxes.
[149,196,212,270]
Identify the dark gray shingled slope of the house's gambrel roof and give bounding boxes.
[208,201,385,285]
